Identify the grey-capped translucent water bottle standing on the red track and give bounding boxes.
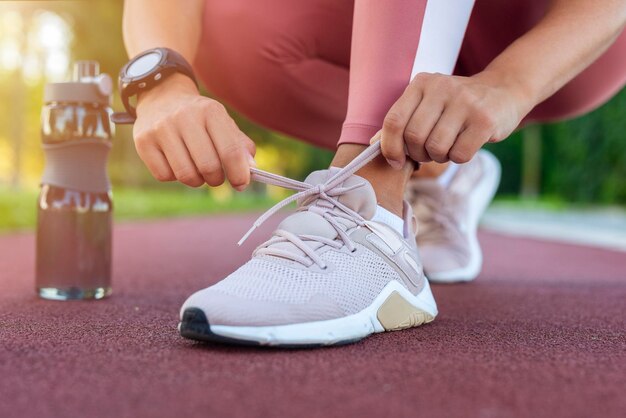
[35,61,114,300]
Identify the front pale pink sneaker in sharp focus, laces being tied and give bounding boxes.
[179,143,437,347]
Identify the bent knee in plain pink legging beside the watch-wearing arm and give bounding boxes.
[195,0,353,149]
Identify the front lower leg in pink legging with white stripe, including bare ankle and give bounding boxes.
[333,0,473,214]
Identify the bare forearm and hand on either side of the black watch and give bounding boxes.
[124,0,255,190]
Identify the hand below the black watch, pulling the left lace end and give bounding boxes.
[133,74,255,190]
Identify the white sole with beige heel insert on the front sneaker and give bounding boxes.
[204,280,437,346]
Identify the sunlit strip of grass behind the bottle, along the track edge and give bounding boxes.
[0,187,275,233]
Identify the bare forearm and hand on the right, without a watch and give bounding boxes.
[381,0,626,171]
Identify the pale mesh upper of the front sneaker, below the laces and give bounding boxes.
[185,244,398,326]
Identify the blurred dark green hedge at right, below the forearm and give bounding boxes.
[486,90,626,204]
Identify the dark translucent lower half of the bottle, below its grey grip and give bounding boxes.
[35,184,113,300]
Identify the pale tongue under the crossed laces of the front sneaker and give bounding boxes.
[264,167,377,255]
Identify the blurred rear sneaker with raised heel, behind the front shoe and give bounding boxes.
[406,150,500,283]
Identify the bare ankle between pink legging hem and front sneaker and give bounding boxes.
[331,144,414,217]
